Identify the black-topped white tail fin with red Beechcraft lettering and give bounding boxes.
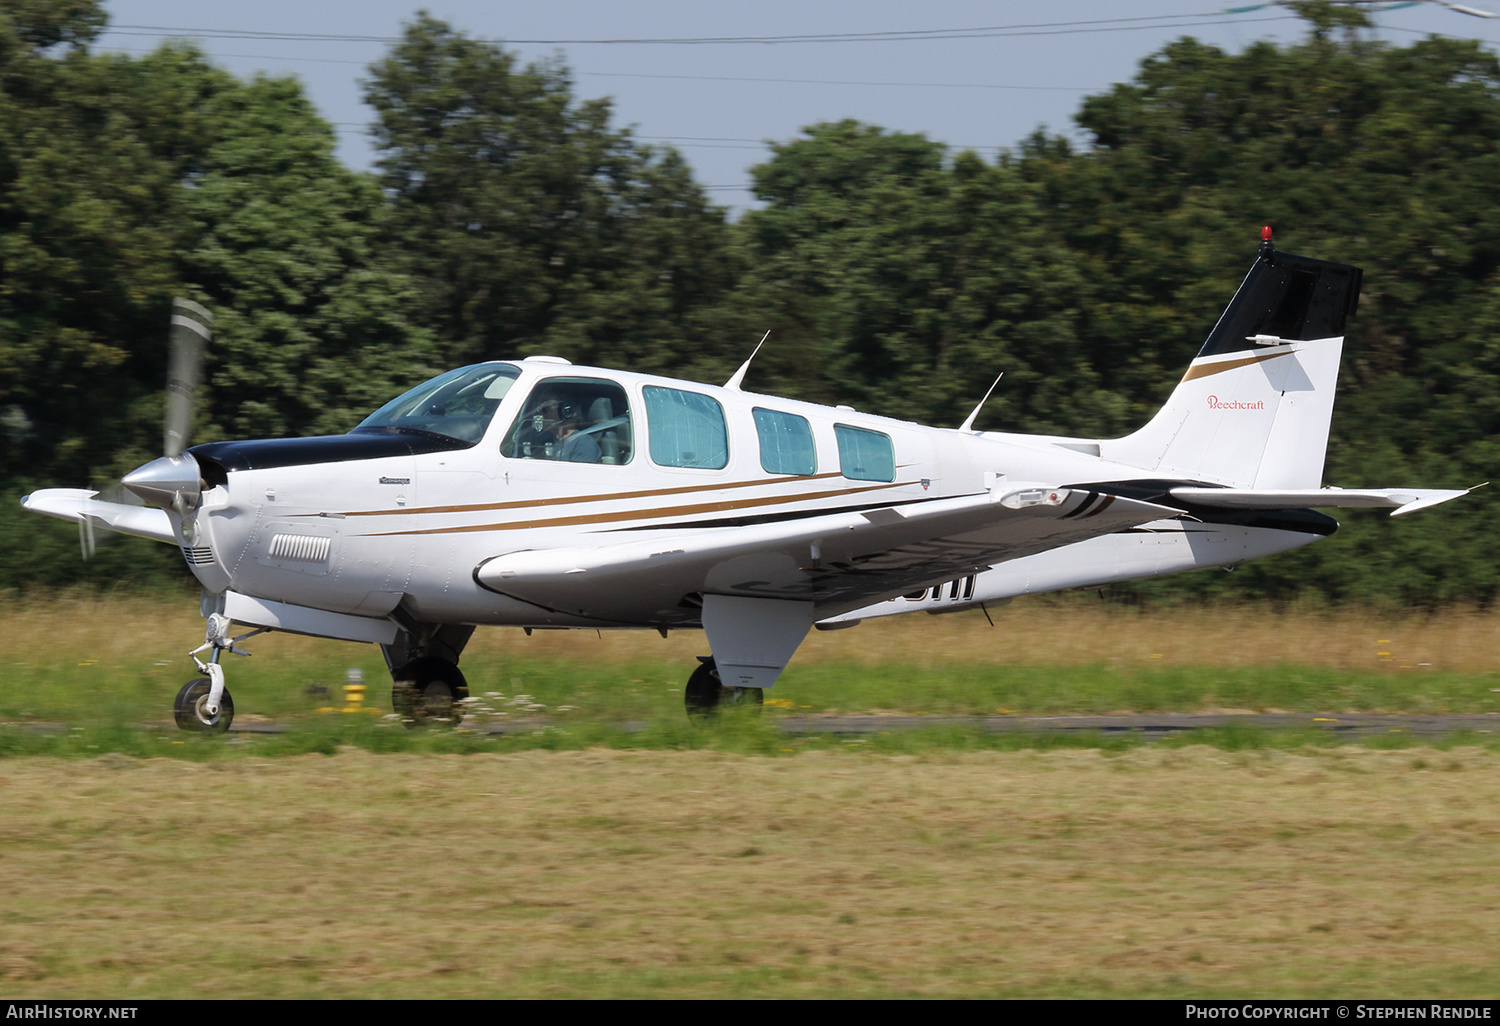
[1100,230,1361,489]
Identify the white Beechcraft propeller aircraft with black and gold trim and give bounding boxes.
[23,228,1467,732]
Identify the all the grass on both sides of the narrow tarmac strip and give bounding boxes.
[0,596,1500,999]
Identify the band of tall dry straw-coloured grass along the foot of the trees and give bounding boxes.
[0,594,1500,674]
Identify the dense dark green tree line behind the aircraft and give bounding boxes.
[0,0,1500,606]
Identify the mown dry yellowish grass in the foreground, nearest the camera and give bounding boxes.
[0,747,1500,999]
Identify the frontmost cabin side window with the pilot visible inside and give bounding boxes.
[500,378,633,465]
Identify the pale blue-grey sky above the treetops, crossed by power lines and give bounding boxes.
[101,0,1500,209]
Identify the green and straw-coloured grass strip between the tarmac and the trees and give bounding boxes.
[0,596,1500,726]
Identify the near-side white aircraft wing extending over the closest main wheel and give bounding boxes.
[474,482,1182,626]
